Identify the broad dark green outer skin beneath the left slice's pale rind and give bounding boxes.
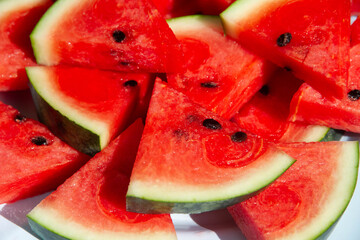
[30,84,101,156]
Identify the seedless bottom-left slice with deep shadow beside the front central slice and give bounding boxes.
[28,121,176,239]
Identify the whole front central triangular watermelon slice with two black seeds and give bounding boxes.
[127,80,293,213]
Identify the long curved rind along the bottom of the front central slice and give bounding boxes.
[126,151,295,214]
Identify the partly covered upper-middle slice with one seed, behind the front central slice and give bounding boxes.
[167,15,275,119]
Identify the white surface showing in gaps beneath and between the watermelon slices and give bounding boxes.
[0,91,360,240]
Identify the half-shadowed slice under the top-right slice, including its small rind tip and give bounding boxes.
[232,68,342,142]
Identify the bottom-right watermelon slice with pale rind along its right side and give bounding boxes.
[228,142,359,240]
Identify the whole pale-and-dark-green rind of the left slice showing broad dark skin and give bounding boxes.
[26,67,105,155]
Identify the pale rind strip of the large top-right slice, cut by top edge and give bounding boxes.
[220,0,290,39]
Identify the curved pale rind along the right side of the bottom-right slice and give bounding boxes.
[278,141,359,240]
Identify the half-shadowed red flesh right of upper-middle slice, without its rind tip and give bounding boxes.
[232,69,306,142]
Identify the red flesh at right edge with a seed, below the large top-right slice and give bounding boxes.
[290,44,360,133]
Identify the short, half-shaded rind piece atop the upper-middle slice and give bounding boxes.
[167,15,223,35]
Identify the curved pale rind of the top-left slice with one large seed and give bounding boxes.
[30,0,90,66]
